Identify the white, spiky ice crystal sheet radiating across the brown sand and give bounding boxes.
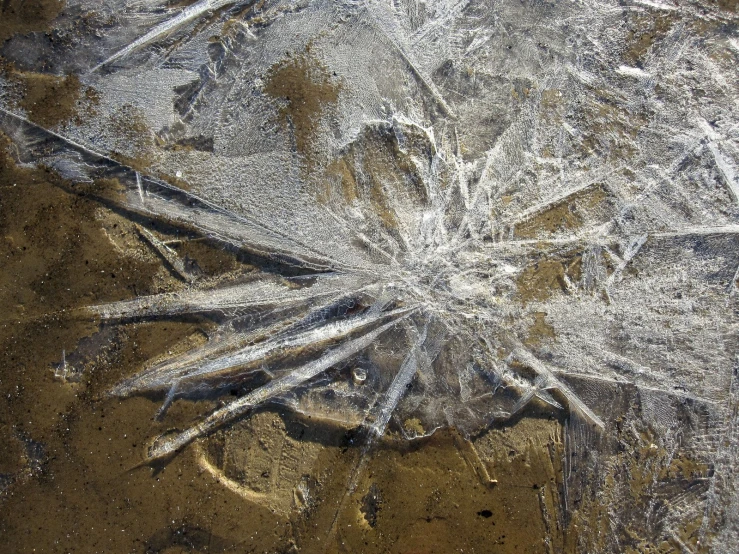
[0,0,739,552]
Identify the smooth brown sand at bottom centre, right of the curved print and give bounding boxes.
[330,419,563,554]
